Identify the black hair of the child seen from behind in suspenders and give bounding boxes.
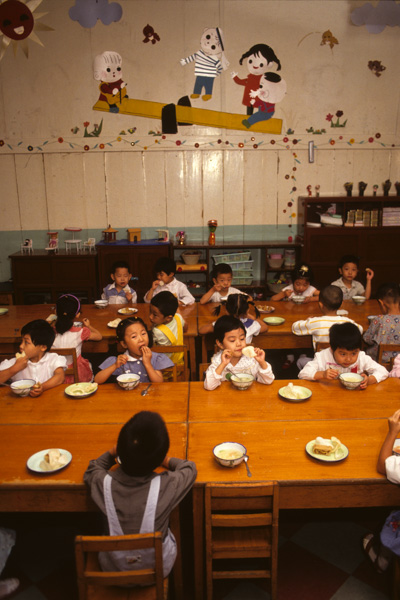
[117,410,169,477]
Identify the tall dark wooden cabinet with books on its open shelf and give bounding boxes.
[298,196,400,293]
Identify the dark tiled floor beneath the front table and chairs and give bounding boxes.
[0,509,392,600]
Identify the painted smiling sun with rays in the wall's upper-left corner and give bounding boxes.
[0,0,54,60]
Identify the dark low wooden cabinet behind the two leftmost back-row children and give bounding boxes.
[96,240,172,302]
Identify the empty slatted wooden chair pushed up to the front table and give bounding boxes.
[205,481,279,600]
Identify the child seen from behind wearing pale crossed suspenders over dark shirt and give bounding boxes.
[84,411,197,577]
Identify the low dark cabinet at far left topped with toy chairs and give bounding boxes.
[9,250,97,304]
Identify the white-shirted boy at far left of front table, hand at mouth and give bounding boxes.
[0,319,67,397]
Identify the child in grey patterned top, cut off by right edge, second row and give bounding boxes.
[364,283,400,362]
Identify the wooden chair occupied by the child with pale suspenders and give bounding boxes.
[75,531,168,600]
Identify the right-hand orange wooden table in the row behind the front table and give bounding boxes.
[198,300,381,362]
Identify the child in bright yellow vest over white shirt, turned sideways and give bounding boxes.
[150,292,187,365]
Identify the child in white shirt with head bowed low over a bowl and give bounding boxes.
[299,323,389,389]
